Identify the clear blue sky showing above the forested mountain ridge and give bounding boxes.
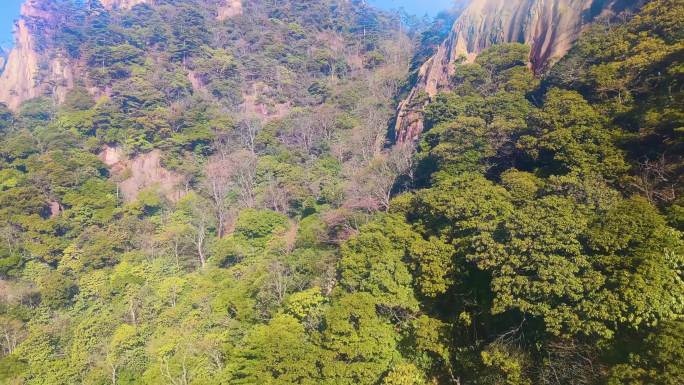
[0,0,453,48]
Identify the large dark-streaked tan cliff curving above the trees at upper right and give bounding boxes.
[395,0,640,142]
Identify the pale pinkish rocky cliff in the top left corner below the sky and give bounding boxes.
[0,0,74,109]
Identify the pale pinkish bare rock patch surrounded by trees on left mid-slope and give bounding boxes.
[100,146,185,202]
